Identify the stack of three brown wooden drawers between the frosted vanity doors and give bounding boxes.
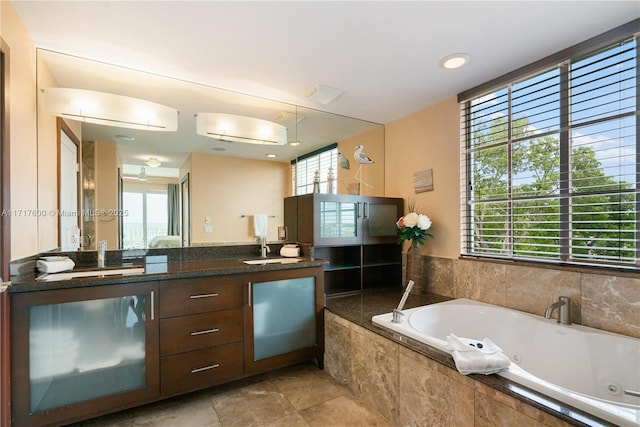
[159,275,245,397]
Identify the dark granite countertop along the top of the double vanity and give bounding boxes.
[8,256,328,293]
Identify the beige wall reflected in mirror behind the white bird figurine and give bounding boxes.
[338,126,385,196]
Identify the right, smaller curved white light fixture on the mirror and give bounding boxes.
[196,113,287,145]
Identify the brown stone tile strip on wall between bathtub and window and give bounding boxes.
[414,255,640,338]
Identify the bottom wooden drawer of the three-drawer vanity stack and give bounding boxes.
[160,342,243,396]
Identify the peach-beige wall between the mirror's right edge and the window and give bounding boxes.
[385,98,460,258]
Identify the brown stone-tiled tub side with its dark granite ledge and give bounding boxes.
[325,291,609,427]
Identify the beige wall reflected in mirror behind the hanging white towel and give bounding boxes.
[183,153,291,245]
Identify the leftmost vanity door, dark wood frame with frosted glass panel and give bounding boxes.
[10,282,160,427]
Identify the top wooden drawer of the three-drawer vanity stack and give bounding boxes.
[159,276,243,318]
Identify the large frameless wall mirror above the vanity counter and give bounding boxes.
[37,50,384,252]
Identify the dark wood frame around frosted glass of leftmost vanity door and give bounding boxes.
[11,281,160,426]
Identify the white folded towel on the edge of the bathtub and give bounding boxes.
[447,334,511,375]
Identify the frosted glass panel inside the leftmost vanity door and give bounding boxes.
[29,295,148,413]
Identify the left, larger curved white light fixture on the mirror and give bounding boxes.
[44,88,178,132]
